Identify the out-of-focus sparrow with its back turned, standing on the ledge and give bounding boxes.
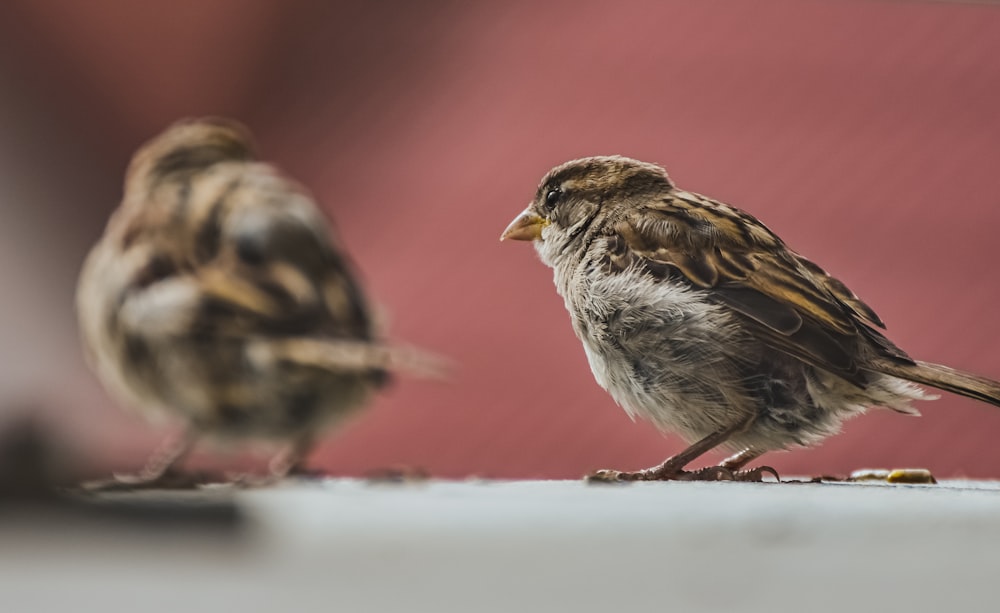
[77,118,422,484]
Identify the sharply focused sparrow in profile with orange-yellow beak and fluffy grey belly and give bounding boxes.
[501,156,1000,481]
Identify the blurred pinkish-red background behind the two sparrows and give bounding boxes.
[0,0,1000,478]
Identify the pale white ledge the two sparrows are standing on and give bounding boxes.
[0,479,1000,613]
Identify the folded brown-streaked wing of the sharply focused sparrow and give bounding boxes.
[607,190,909,384]
